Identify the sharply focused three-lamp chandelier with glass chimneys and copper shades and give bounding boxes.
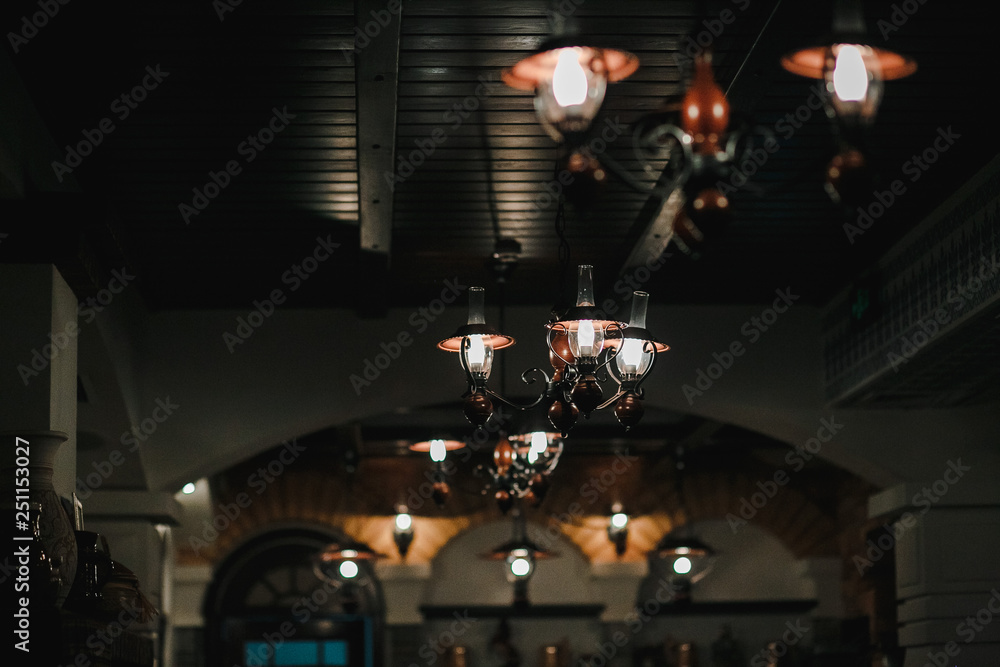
[438,264,669,437]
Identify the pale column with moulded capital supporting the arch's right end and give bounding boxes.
[864,457,1000,667]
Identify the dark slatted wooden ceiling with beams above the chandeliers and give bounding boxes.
[0,0,997,312]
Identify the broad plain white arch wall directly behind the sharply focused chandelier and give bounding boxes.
[88,298,1000,491]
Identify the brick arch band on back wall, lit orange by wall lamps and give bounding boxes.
[178,444,866,576]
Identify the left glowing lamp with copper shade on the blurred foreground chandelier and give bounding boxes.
[501,26,639,144]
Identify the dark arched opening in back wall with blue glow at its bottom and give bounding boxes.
[204,528,385,667]
